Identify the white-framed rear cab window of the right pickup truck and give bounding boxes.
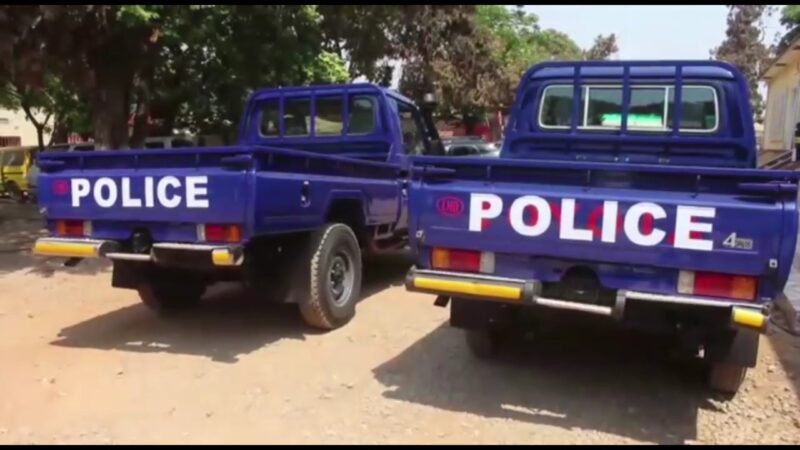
[537,84,719,133]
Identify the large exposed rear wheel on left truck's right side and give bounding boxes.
[292,223,362,330]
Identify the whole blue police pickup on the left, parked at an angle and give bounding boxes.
[34,84,444,329]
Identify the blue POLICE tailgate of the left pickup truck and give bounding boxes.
[39,147,251,240]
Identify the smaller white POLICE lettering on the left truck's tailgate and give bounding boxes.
[70,175,209,209]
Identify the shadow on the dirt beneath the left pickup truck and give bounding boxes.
[51,253,408,363]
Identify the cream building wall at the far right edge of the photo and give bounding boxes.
[762,59,800,154]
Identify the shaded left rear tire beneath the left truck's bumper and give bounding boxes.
[136,270,206,314]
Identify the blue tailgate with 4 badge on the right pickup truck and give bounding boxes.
[409,158,797,295]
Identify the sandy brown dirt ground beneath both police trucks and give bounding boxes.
[0,203,800,444]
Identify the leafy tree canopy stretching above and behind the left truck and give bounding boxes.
[0,5,616,148]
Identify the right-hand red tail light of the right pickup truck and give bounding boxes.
[678,270,758,301]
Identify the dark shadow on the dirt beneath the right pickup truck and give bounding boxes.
[374,319,717,443]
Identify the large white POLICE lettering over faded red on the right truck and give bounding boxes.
[469,193,716,251]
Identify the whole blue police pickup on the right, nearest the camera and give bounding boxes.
[406,61,798,395]
